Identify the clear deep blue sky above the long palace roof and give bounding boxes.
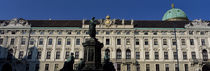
[0,0,210,20]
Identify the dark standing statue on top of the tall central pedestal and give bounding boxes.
[89,17,96,39]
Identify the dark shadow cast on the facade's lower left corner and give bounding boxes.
[0,46,40,71]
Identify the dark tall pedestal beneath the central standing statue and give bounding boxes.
[81,38,103,71]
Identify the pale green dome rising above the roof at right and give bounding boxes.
[162,8,188,21]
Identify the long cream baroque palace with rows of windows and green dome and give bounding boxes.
[0,7,210,71]
